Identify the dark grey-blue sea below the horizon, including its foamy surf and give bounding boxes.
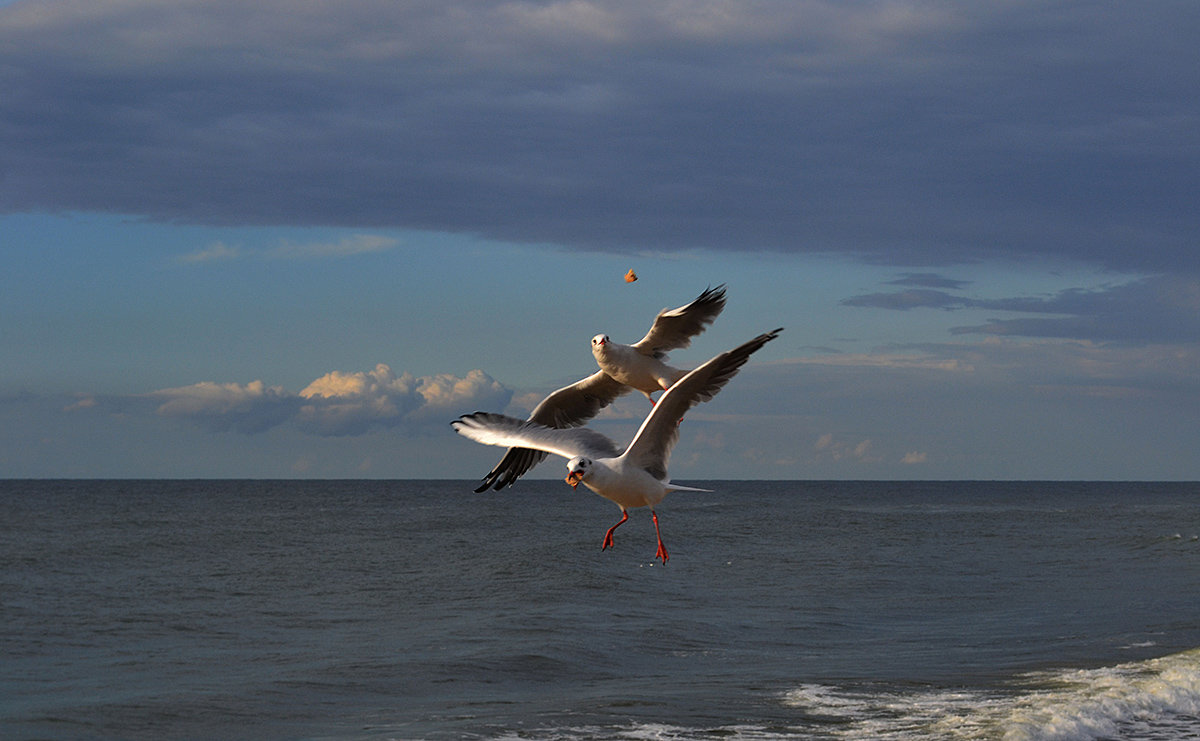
[0,481,1200,740]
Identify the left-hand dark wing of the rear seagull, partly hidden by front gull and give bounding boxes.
[475,371,630,492]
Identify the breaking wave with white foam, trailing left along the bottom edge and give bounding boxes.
[472,649,1200,741]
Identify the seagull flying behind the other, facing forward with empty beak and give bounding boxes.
[475,284,725,492]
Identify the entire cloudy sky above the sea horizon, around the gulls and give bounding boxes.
[0,0,1200,486]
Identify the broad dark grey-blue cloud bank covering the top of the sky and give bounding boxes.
[0,0,1200,270]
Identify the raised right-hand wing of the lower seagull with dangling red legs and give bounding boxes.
[625,327,784,480]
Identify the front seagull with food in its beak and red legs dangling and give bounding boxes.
[450,327,784,564]
